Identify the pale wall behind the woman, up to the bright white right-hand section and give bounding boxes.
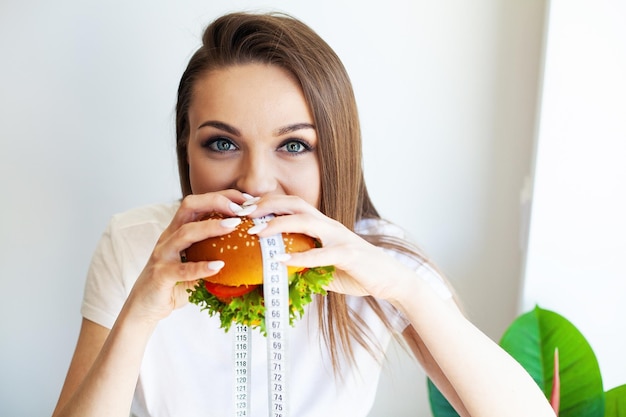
[0,0,544,417]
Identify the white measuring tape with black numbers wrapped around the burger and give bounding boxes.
[233,215,289,417]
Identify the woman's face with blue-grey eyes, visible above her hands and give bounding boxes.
[187,64,320,207]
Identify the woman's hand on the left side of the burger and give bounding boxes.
[125,190,254,322]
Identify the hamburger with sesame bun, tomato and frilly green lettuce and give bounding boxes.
[185,213,334,334]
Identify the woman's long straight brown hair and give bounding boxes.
[176,13,420,367]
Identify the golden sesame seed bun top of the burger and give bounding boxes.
[185,213,316,287]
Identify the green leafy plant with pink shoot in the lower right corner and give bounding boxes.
[428,306,626,417]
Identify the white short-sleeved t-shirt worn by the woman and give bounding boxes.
[81,203,438,417]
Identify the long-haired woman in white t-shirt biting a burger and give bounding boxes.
[54,14,553,417]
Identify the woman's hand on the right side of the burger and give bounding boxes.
[246,195,408,299]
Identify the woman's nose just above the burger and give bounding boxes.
[235,152,278,196]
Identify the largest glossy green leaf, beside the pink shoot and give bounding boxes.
[495,307,604,417]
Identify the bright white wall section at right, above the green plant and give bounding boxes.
[523,0,626,389]
